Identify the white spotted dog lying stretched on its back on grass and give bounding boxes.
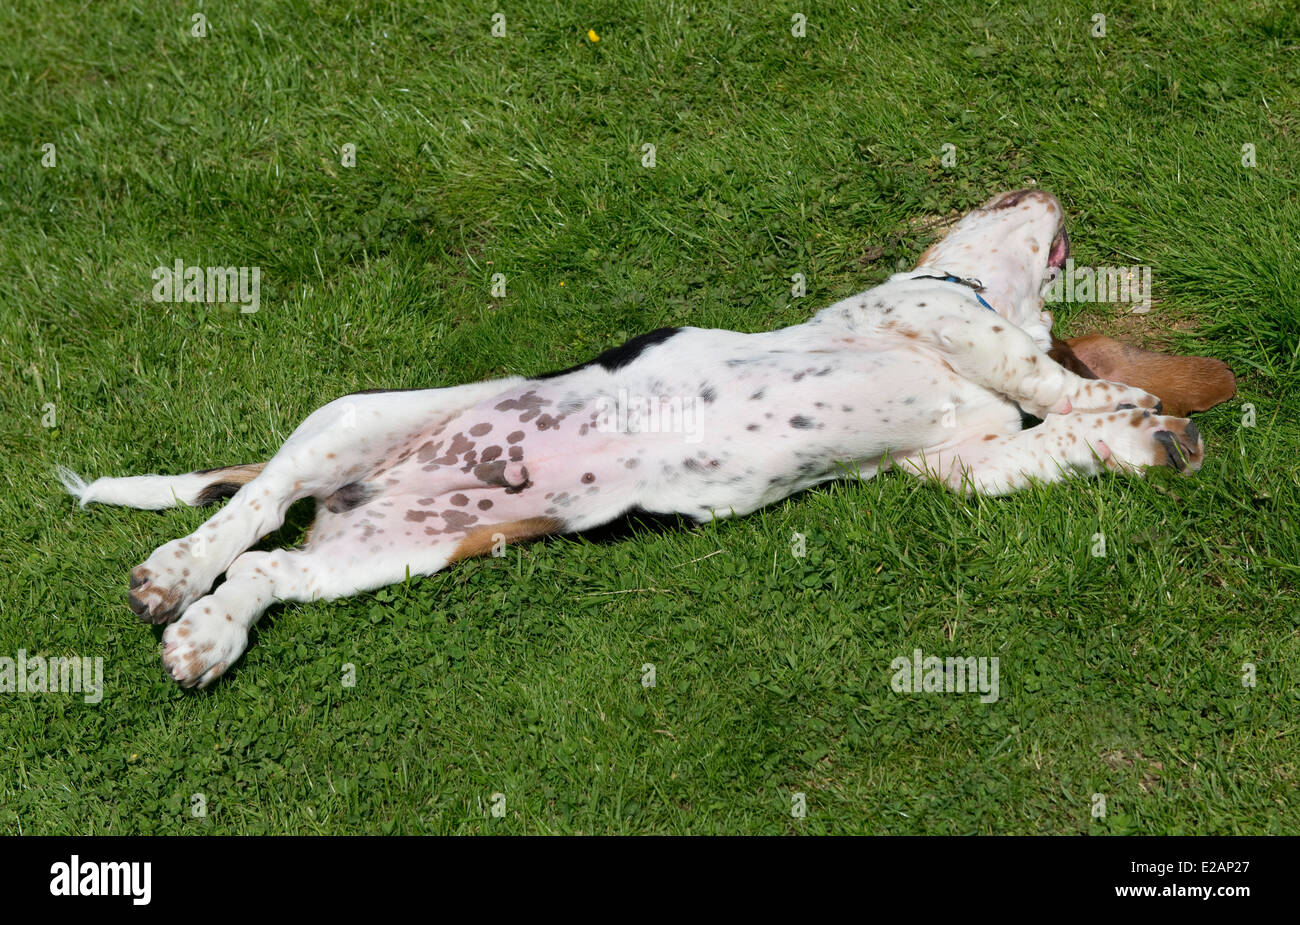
[60,190,1232,687]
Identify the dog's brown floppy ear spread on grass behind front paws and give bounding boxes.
[1050,334,1236,417]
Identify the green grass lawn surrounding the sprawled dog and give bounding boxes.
[0,0,1300,834]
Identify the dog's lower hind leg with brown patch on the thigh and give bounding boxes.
[163,517,563,687]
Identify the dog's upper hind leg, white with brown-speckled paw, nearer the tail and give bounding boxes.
[129,378,523,624]
